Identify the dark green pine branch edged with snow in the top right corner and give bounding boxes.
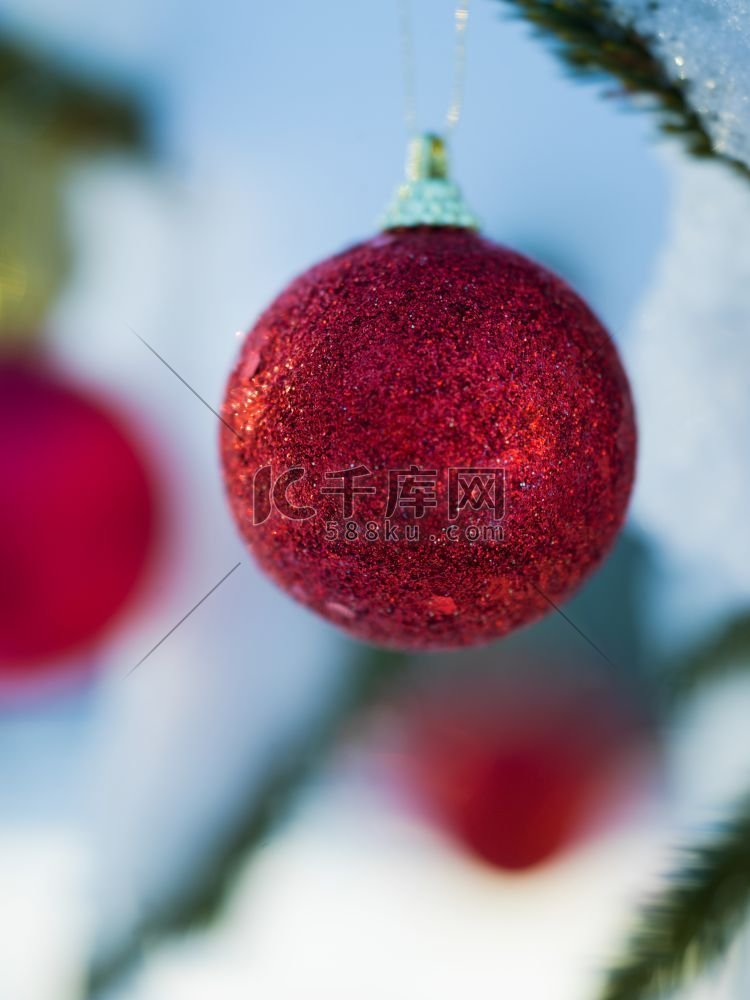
[502,0,750,177]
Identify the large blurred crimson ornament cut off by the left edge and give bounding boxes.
[0,356,157,681]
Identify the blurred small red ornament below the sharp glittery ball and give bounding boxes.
[398,668,653,871]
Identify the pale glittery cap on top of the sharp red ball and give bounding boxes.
[381,132,479,229]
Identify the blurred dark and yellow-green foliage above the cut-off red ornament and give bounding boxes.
[0,36,150,334]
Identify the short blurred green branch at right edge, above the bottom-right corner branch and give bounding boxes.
[667,611,750,709]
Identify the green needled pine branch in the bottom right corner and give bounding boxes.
[599,795,750,1000]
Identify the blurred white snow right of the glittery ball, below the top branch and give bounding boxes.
[625,148,750,628]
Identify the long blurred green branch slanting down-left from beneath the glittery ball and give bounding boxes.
[86,649,406,1000]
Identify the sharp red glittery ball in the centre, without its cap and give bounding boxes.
[222,228,635,649]
